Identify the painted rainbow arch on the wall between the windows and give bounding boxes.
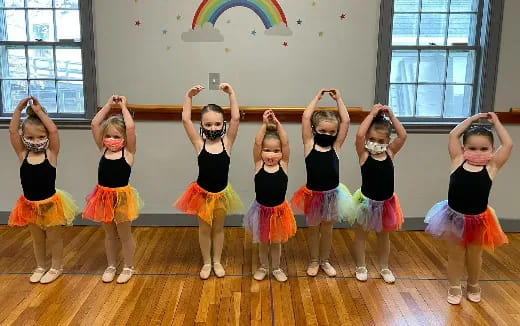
[191,0,287,29]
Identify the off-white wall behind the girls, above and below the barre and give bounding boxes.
[0,0,520,219]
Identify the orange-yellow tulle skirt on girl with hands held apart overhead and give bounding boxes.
[173,182,243,225]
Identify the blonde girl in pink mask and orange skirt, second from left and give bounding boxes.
[83,95,142,284]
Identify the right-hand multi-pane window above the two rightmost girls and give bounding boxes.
[376,0,503,121]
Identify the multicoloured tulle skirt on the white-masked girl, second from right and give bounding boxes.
[348,189,404,232]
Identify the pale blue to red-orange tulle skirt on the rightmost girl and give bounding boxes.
[424,200,508,250]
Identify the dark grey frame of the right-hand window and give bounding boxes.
[374,0,505,126]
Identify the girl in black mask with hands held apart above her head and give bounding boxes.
[174,83,242,280]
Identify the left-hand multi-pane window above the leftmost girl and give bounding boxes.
[0,0,95,118]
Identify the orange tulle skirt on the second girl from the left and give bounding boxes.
[83,185,143,224]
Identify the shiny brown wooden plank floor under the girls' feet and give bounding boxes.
[0,226,520,326]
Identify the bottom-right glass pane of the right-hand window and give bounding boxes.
[444,85,473,118]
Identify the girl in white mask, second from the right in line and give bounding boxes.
[349,104,406,283]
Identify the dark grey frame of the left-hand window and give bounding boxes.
[0,0,97,121]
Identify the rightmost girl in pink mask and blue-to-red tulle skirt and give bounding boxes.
[425,112,513,304]
